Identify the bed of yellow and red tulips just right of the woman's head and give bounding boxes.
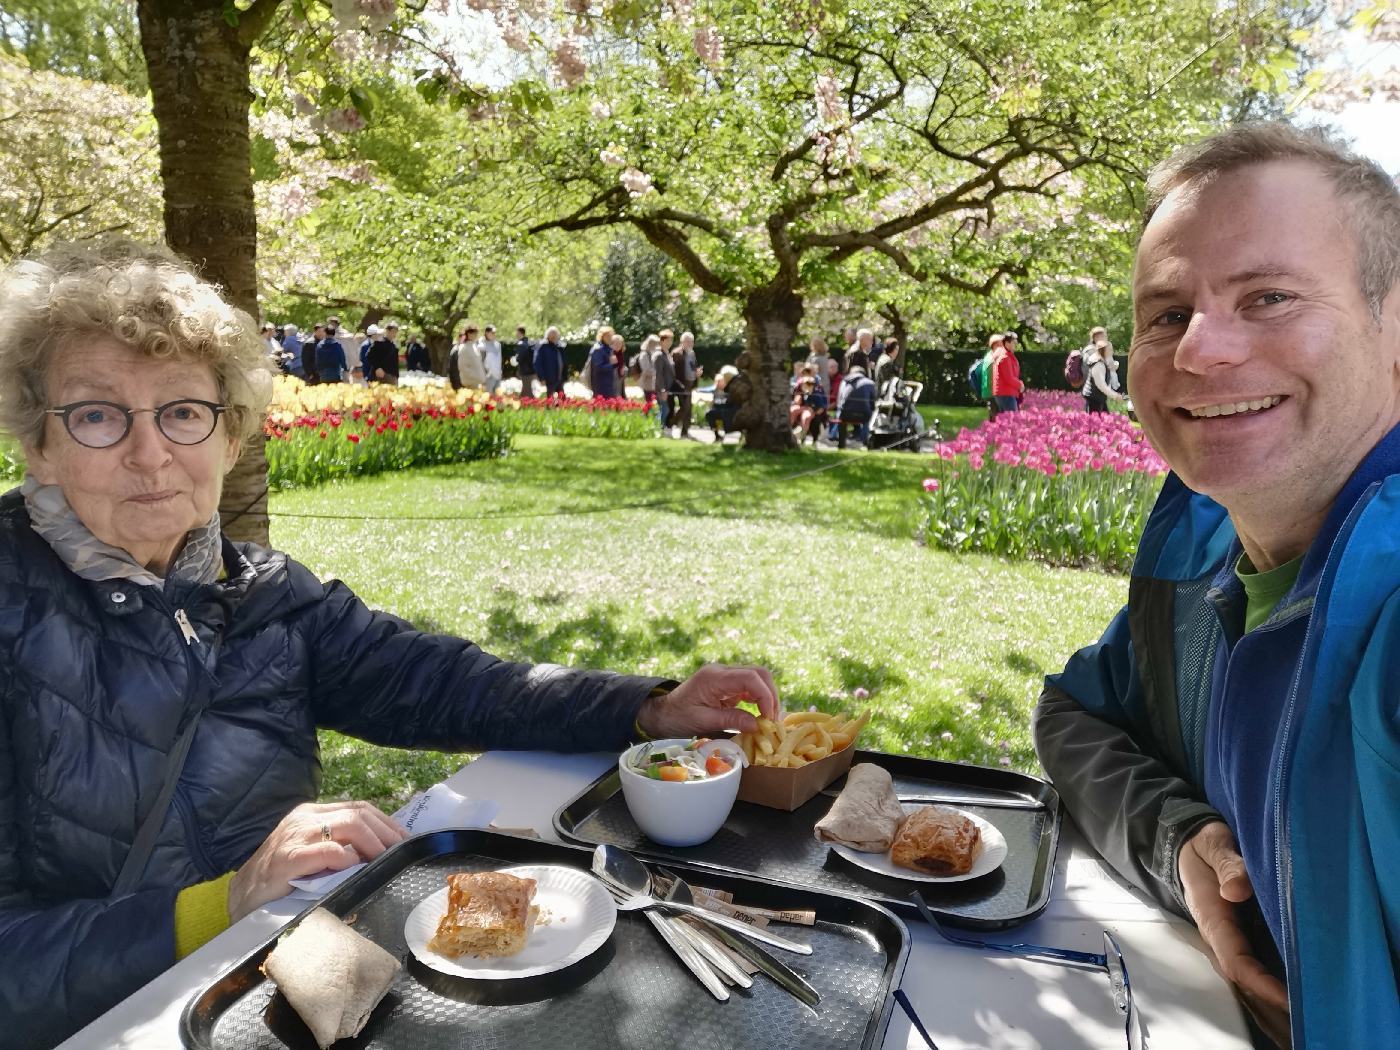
[263,375,657,489]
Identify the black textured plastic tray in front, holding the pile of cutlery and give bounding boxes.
[181,832,909,1050]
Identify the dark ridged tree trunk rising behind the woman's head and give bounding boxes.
[137,0,267,543]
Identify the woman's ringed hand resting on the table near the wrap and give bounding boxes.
[228,802,409,923]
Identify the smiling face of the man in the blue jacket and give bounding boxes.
[1130,160,1400,512]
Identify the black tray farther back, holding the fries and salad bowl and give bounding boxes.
[554,750,1061,930]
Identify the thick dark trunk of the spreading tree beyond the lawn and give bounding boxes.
[736,287,802,452]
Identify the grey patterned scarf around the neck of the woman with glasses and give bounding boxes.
[20,476,223,587]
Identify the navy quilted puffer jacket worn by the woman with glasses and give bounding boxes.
[0,493,673,1049]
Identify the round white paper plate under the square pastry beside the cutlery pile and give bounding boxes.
[403,864,617,980]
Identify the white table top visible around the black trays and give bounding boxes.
[63,752,1250,1050]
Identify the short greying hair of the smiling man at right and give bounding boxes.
[1142,120,1400,323]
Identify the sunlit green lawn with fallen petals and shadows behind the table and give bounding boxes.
[272,431,1127,808]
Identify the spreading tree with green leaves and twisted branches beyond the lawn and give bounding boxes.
[458,0,1287,448]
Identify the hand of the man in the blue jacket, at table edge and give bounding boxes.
[1176,820,1289,1047]
